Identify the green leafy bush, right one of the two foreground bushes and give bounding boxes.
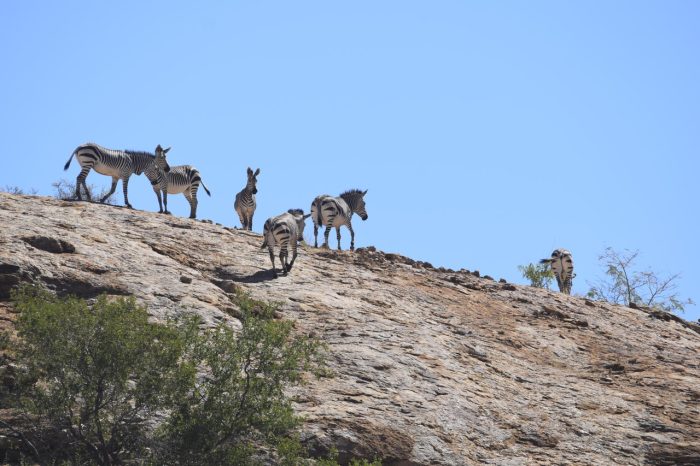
[164,295,323,464]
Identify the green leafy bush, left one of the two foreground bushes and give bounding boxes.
[9,287,191,464]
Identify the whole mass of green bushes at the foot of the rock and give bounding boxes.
[3,286,323,465]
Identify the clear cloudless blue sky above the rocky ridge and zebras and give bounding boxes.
[0,0,700,320]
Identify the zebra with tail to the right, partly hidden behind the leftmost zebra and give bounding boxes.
[146,146,211,218]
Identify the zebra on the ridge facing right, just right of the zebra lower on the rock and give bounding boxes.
[311,189,367,251]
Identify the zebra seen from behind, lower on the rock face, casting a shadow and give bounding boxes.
[260,209,311,278]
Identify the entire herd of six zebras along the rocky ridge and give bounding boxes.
[63,143,575,294]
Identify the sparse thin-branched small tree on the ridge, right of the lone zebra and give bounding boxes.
[588,248,694,312]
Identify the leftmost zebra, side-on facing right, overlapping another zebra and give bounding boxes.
[63,143,170,209]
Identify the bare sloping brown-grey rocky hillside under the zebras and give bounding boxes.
[0,194,700,465]
